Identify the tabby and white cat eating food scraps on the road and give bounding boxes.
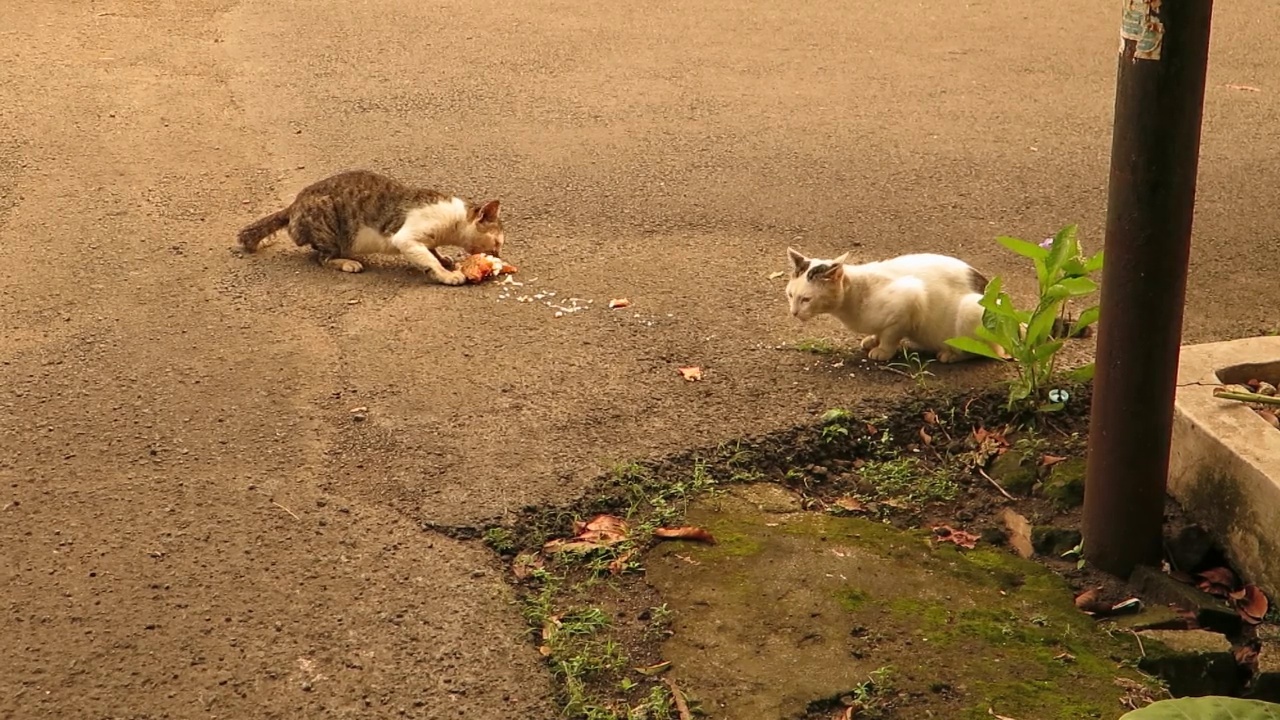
[239,170,503,284]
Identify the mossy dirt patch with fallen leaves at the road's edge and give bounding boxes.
[486,386,1269,719]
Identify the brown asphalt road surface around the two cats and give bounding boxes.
[0,0,1280,719]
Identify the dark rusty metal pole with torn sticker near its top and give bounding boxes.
[1083,0,1213,577]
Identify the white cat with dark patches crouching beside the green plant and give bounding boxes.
[787,247,1004,363]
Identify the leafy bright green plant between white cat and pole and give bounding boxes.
[947,225,1102,411]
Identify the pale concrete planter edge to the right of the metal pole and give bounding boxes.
[1169,337,1280,596]
